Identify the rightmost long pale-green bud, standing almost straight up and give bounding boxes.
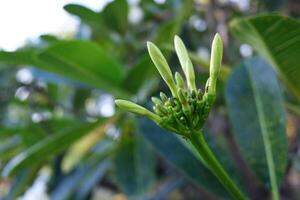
[207,33,223,95]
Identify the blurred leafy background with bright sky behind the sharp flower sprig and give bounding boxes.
[0,0,300,200]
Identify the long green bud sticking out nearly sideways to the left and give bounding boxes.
[115,99,161,123]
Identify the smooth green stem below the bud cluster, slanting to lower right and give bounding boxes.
[190,132,247,200]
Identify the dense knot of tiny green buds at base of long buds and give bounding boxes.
[151,88,210,135]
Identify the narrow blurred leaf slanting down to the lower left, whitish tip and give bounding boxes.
[2,122,99,176]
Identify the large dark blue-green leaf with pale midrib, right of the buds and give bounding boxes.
[226,57,287,191]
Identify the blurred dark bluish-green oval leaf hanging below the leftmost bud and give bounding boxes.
[113,131,155,197]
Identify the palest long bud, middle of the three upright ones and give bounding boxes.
[174,35,196,90]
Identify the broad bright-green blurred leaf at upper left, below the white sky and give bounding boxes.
[36,41,127,96]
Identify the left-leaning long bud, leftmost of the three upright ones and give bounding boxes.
[147,42,176,97]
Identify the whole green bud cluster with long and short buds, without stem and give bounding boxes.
[116,34,223,137]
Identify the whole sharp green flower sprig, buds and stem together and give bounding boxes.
[115,34,246,199]
